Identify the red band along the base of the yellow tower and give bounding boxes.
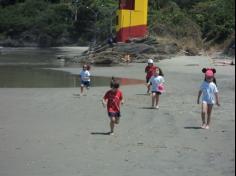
[116,25,147,42]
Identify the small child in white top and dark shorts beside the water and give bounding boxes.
[80,65,91,94]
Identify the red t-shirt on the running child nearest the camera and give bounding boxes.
[103,90,123,112]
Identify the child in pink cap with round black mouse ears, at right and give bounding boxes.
[197,68,220,129]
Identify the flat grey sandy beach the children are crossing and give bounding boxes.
[0,56,235,176]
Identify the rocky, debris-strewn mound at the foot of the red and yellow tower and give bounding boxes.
[67,38,180,65]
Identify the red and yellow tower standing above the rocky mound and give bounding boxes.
[116,0,148,42]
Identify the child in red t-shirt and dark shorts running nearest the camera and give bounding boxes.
[102,81,124,135]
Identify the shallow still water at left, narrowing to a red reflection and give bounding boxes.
[0,48,142,88]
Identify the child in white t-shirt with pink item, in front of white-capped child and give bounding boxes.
[147,69,165,109]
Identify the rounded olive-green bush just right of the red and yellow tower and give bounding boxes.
[149,2,201,47]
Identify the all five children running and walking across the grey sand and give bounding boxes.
[80,59,220,135]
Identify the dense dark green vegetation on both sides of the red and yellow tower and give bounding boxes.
[0,0,235,46]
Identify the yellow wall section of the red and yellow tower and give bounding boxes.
[116,0,148,31]
